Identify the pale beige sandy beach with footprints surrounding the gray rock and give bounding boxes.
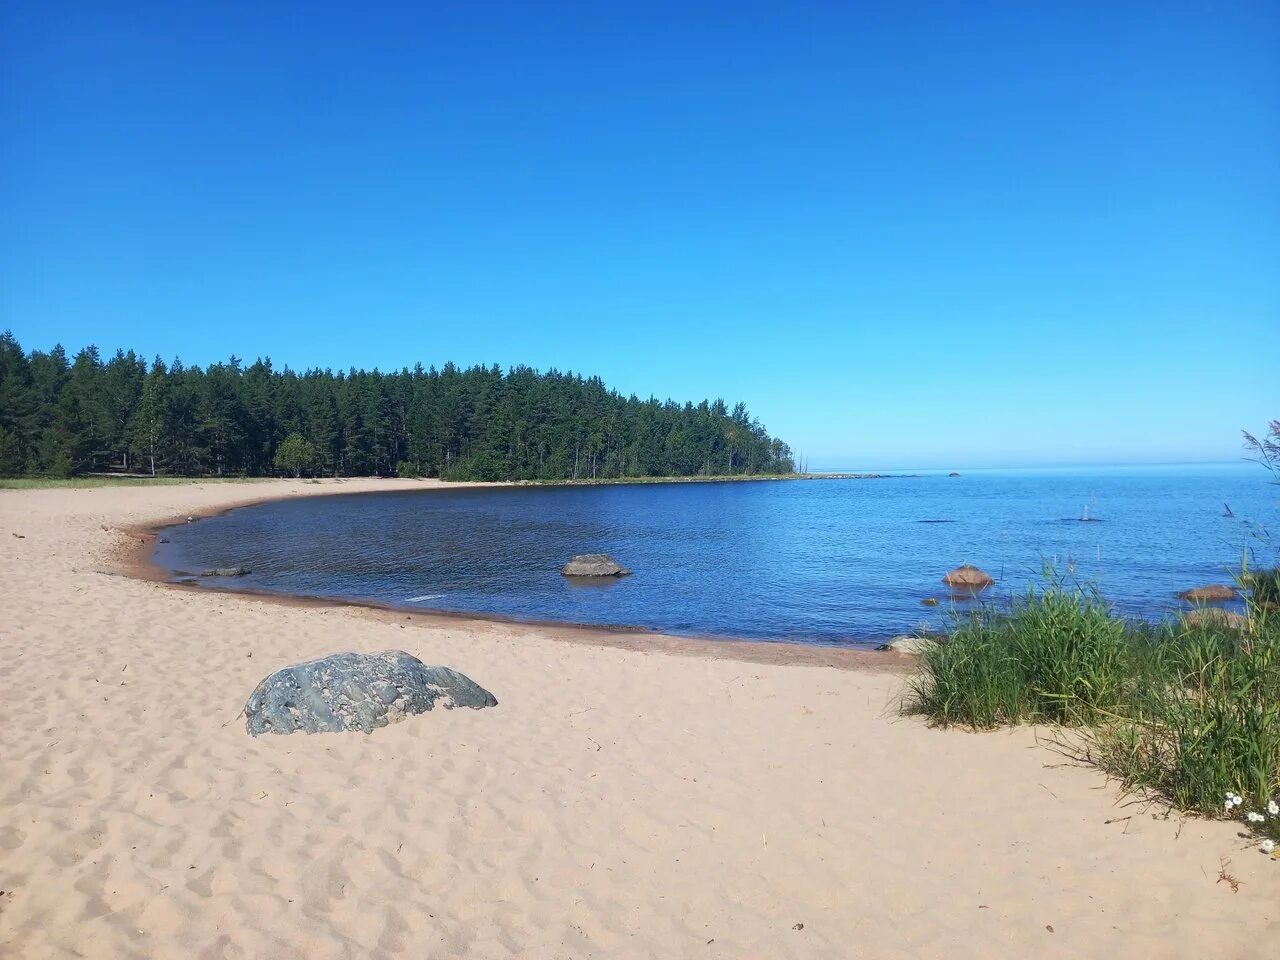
[0,481,1280,959]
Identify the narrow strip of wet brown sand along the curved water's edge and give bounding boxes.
[118,477,916,673]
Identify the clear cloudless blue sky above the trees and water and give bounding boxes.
[0,0,1280,467]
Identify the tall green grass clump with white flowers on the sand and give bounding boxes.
[905,584,1280,841]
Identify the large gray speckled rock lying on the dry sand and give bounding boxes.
[244,650,498,736]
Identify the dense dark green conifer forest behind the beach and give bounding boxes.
[0,333,794,480]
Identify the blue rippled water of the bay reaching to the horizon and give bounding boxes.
[156,465,1280,644]
